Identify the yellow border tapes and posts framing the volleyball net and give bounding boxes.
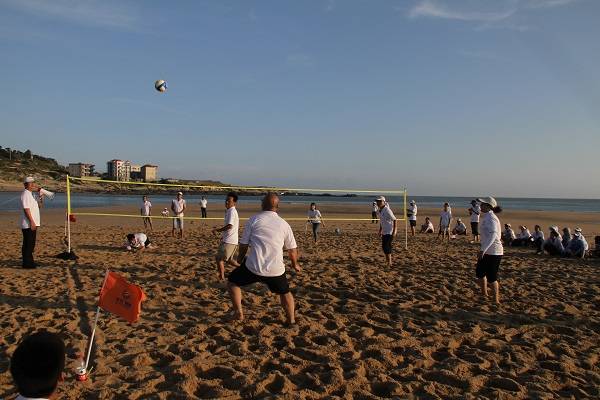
[65,175,408,252]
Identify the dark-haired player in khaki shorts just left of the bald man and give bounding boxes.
[212,192,240,281]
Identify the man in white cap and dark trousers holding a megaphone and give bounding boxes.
[21,176,41,269]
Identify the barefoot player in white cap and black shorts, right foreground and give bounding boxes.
[475,197,504,304]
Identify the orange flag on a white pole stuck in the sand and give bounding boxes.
[98,271,146,323]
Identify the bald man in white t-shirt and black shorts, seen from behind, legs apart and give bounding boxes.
[228,193,301,325]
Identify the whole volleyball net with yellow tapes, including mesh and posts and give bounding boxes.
[65,175,408,252]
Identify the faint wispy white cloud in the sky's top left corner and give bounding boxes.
[2,0,138,29]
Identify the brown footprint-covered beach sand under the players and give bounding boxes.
[0,204,600,399]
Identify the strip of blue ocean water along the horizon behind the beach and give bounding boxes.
[0,192,600,213]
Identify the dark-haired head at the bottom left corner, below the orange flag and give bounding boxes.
[10,331,65,398]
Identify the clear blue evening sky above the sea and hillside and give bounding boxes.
[0,0,600,198]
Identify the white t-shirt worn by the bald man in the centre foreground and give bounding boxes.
[240,211,298,276]
